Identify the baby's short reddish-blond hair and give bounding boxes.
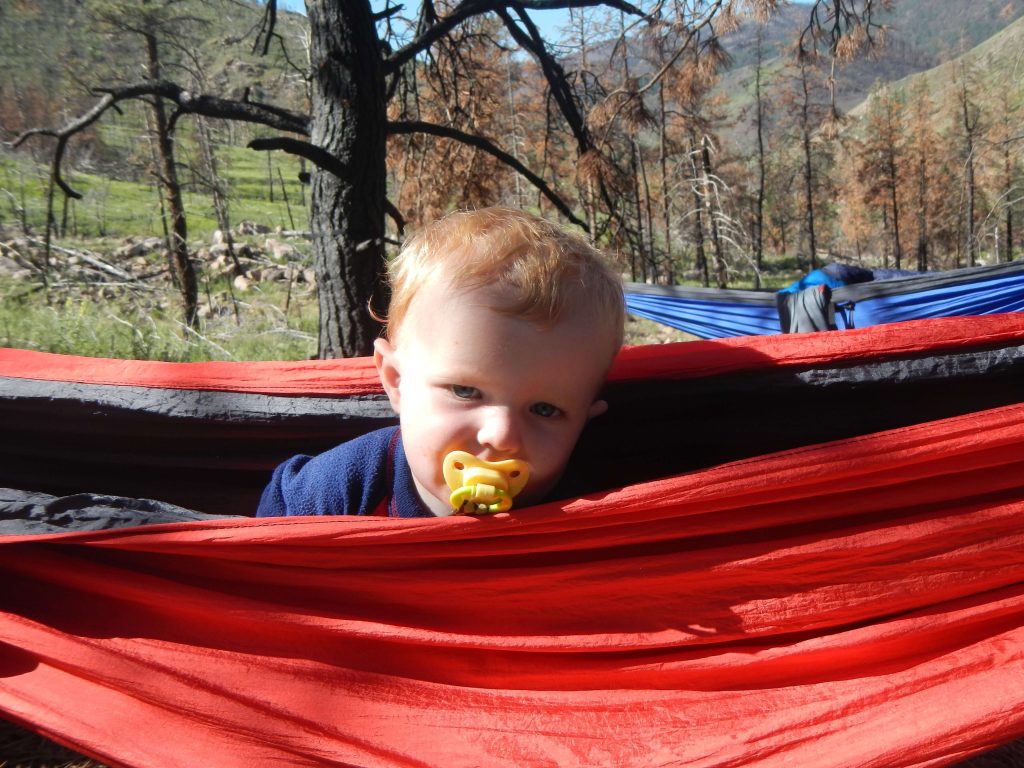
[387,207,626,348]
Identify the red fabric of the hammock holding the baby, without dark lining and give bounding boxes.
[0,315,1024,768]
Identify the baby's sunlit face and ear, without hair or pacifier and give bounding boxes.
[375,284,612,515]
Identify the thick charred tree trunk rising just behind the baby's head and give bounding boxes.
[306,0,388,358]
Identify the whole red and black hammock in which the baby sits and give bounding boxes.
[0,315,1024,768]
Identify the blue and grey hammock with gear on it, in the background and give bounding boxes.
[626,261,1024,339]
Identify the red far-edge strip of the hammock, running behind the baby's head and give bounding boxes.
[0,313,1024,396]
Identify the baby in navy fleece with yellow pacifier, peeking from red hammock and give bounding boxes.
[257,208,625,517]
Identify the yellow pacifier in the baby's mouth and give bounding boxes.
[441,451,529,515]
